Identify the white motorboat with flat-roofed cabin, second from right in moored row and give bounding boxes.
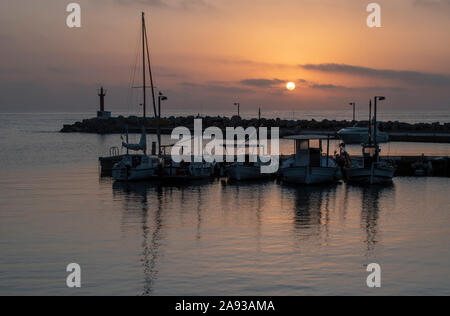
[280,135,340,184]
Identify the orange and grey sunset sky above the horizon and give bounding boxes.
[0,0,450,112]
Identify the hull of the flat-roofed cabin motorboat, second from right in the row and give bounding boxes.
[281,166,338,184]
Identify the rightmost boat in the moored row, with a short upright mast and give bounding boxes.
[344,97,396,184]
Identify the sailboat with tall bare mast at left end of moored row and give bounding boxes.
[112,13,160,181]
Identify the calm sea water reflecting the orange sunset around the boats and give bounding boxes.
[0,114,450,295]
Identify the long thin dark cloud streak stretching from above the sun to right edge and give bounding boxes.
[300,64,450,86]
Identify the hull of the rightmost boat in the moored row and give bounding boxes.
[345,167,395,184]
